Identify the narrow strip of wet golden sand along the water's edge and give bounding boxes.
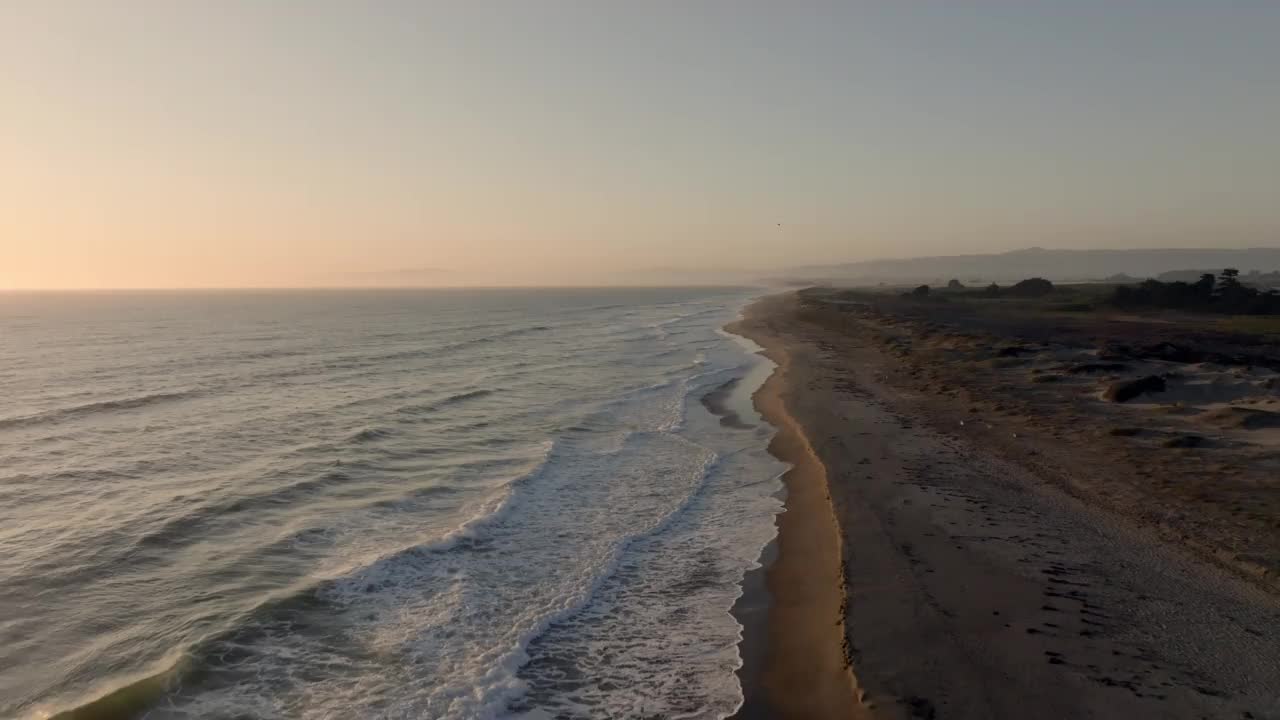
[724,304,868,720]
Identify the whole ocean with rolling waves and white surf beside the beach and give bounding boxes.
[0,288,783,720]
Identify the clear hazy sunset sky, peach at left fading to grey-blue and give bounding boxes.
[0,0,1280,288]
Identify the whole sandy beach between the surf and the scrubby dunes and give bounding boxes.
[730,293,1280,719]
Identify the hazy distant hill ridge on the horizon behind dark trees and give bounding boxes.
[778,247,1280,284]
